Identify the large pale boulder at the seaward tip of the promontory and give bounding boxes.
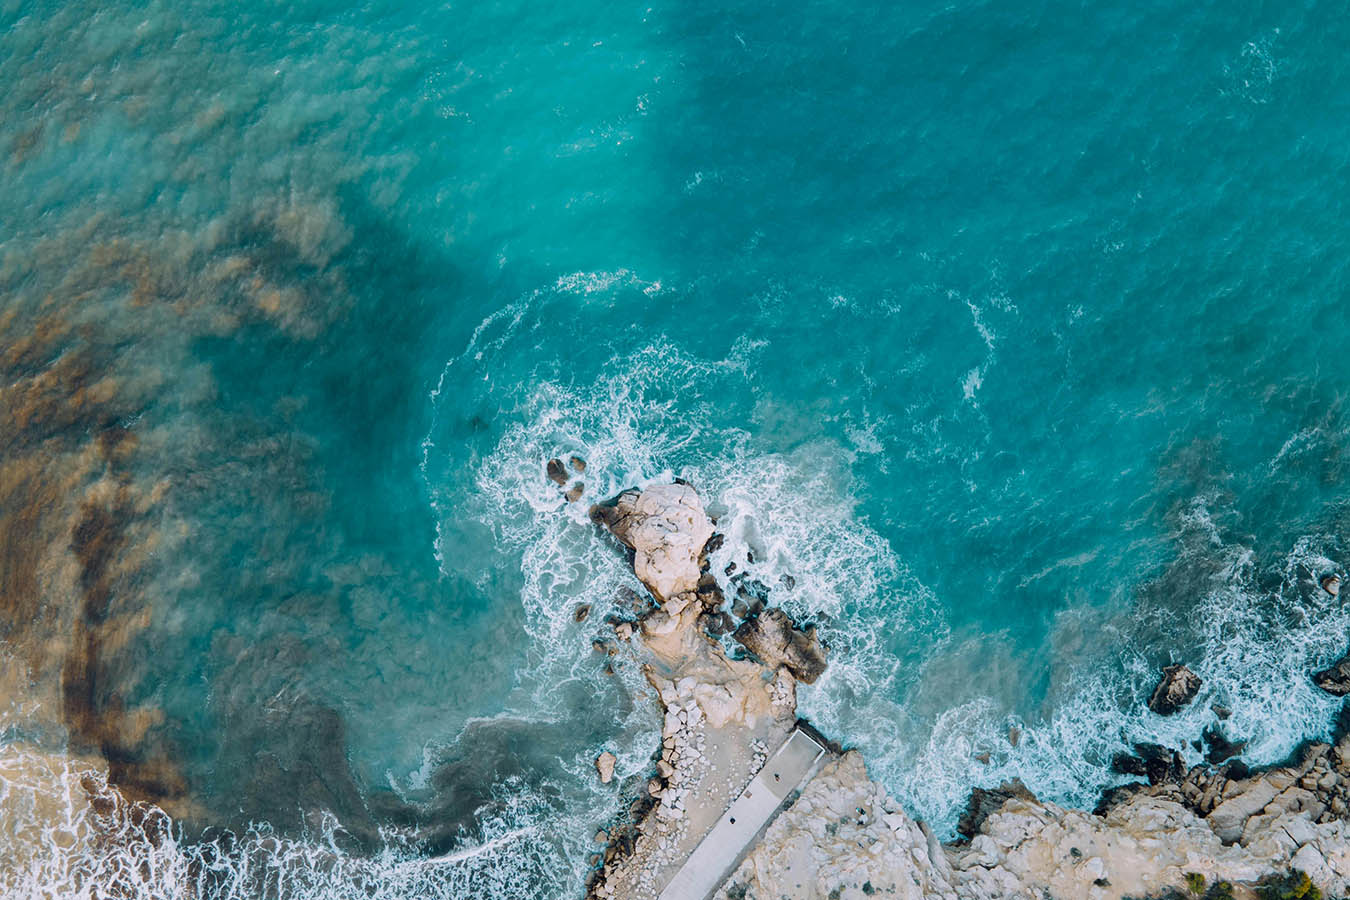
[590,484,713,603]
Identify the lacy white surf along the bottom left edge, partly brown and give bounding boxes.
[0,723,586,900]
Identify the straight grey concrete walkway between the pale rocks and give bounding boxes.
[660,729,828,900]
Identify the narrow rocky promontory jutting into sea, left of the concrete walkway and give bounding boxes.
[587,483,797,900]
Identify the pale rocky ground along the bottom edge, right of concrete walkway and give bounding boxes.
[716,753,1350,900]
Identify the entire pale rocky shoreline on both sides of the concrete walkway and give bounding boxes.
[572,474,1350,900]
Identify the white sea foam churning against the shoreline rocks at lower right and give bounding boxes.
[845,498,1350,834]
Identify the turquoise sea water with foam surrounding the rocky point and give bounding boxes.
[0,0,1350,897]
